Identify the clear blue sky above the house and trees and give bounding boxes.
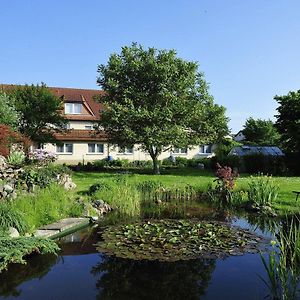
[0,0,300,132]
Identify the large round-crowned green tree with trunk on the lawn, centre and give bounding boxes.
[98,44,228,173]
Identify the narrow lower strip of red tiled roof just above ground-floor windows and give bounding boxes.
[54,129,107,142]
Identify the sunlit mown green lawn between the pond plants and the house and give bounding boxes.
[73,168,300,212]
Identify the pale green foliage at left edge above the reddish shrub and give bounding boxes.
[0,91,20,129]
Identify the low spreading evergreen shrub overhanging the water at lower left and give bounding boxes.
[0,236,59,272]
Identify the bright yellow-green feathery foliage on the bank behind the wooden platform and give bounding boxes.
[12,184,83,231]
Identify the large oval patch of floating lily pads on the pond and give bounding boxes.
[97,219,263,261]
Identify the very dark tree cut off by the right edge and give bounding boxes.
[274,90,300,153]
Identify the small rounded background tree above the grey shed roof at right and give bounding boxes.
[243,118,280,146]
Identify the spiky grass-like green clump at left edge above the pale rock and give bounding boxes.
[0,201,28,236]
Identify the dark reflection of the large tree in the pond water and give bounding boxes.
[91,255,215,300]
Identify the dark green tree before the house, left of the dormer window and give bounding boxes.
[11,83,66,144]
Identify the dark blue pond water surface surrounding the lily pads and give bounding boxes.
[0,204,296,300]
